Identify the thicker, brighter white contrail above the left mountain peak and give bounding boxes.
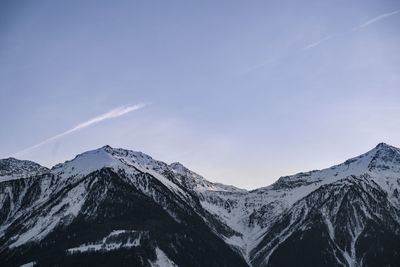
[12,103,148,156]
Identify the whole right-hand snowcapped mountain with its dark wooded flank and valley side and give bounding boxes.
[198,143,400,266]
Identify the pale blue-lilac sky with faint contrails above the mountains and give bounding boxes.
[0,0,400,189]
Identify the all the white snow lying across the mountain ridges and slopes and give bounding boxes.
[0,144,400,266]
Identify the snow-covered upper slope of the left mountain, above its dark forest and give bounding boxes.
[0,146,193,247]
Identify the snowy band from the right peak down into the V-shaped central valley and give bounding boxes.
[192,143,400,261]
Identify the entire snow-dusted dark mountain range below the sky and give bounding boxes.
[0,143,400,266]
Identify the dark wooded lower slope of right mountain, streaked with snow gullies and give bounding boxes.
[251,174,400,266]
